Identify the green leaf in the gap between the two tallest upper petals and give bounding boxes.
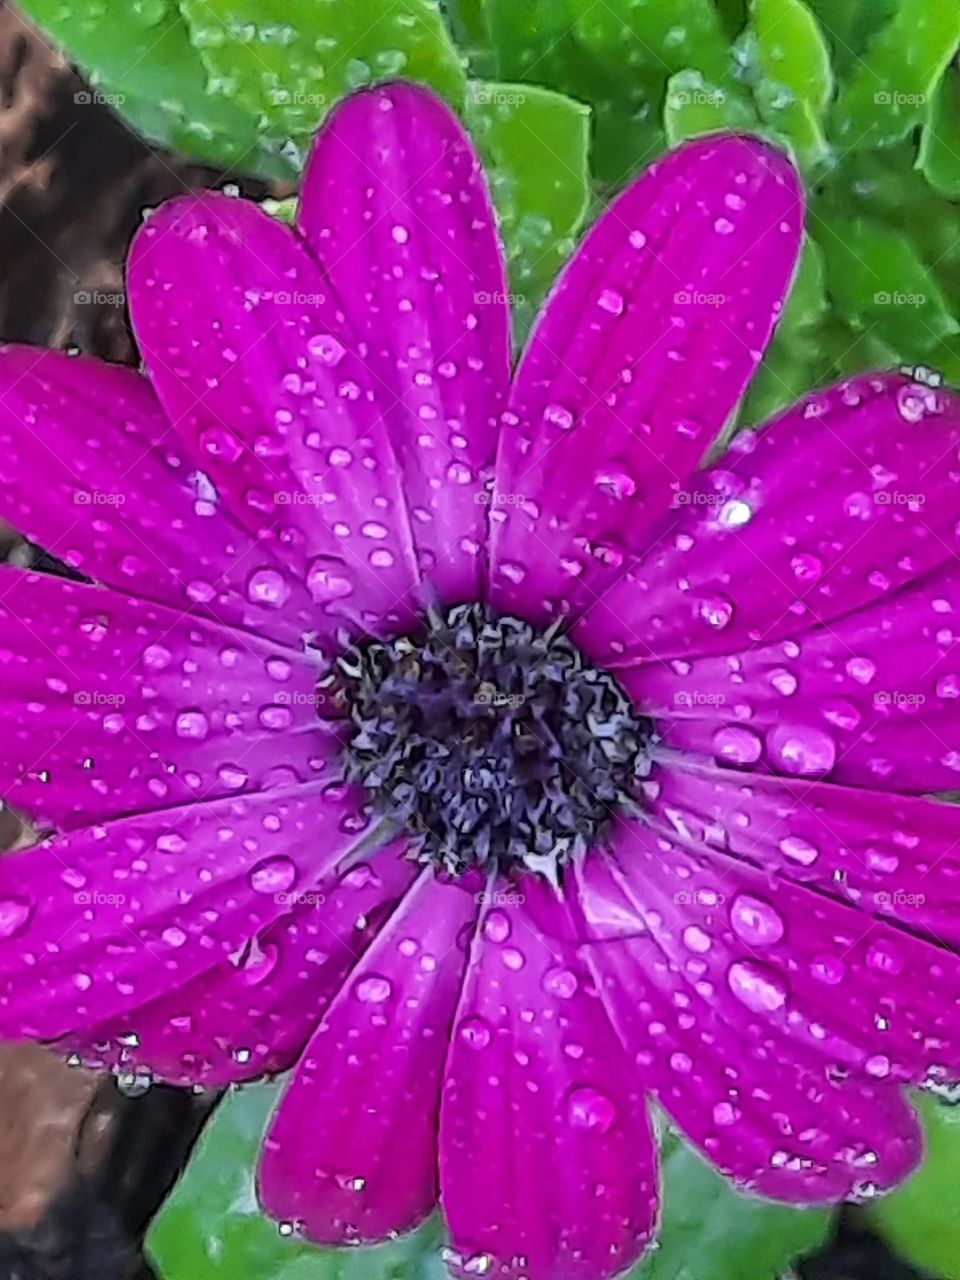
[466,82,590,338]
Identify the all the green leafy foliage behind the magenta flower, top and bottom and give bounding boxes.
[13,0,960,1280]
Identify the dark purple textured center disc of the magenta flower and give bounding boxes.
[337,604,653,883]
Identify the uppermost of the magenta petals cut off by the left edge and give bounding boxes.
[0,347,311,641]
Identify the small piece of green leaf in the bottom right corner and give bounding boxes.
[867,1093,960,1280]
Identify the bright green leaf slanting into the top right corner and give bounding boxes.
[833,0,960,150]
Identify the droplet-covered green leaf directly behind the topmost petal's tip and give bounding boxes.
[180,0,466,163]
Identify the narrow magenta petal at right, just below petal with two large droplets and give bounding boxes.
[646,763,960,947]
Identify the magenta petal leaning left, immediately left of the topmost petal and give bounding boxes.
[128,195,420,640]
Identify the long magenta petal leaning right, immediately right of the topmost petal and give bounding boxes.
[493,136,803,616]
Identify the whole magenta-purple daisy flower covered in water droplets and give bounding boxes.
[0,86,960,1280]
